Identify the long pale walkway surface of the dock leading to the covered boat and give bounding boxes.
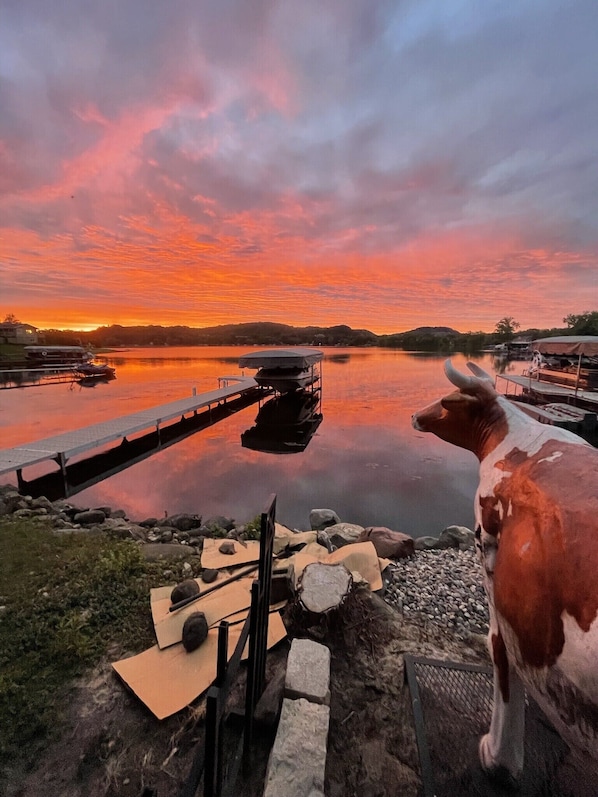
[0,377,259,474]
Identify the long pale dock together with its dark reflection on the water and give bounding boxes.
[0,376,270,500]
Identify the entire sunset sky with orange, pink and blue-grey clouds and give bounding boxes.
[0,0,598,333]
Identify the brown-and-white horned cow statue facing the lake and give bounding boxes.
[412,360,598,789]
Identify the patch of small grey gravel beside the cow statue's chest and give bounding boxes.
[384,548,488,639]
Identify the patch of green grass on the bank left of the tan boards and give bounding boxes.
[0,519,185,765]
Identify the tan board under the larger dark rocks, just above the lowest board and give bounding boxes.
[150,576,254,648]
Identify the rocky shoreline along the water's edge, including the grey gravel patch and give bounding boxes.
[0,478,488,640]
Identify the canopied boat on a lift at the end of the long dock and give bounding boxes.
[239,347,324,393]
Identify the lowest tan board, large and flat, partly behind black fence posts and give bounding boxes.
[112,613,286,719]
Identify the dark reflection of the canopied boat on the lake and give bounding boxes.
[241,390,324,454]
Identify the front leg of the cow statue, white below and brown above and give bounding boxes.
[479,625,525,788]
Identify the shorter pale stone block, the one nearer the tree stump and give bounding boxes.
[285,639,330,705]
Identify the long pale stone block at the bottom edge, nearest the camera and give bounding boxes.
[264,698,330,797]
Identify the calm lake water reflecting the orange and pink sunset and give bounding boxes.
[0,347,522,536]
